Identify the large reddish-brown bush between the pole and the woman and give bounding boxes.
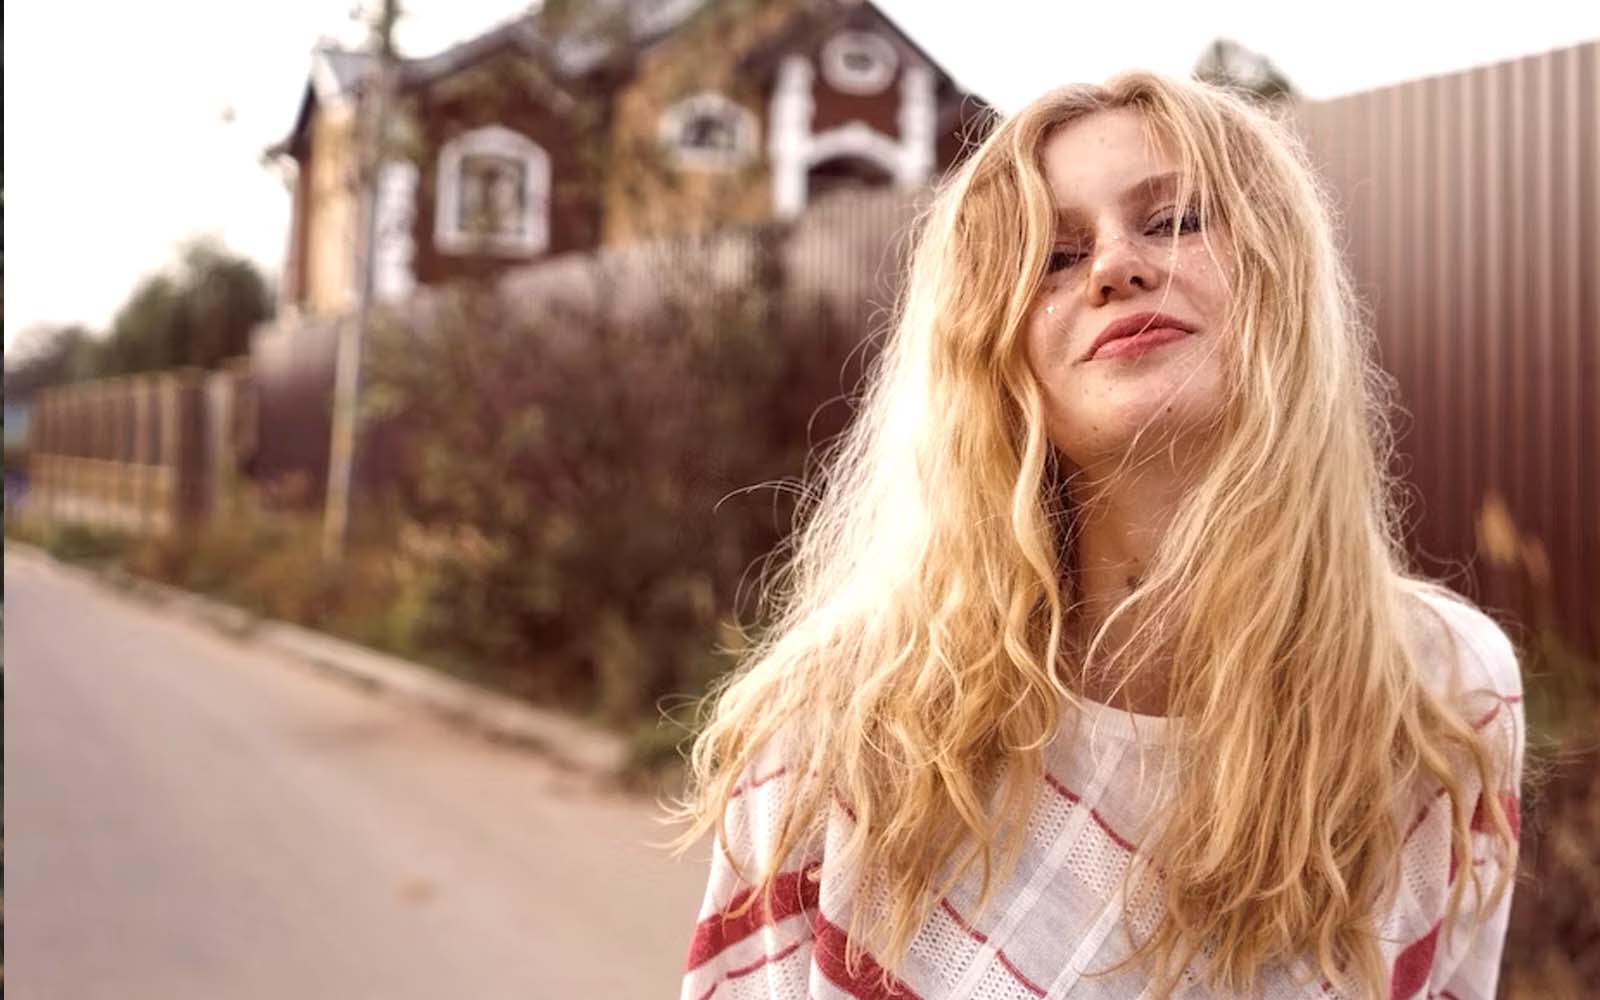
[366,238,866,725]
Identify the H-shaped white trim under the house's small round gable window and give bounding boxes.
[768,56,938,218]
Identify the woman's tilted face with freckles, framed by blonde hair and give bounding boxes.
[1026,109,1229,469]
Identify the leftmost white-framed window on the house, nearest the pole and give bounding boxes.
[434,125,550,256]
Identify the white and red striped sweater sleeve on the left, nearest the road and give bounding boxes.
[680,755,819,1000]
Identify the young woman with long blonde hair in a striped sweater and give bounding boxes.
[682,72,1523,1000]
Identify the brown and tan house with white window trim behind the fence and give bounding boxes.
[269,0,987,314]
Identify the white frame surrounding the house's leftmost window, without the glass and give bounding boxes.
[434,125,550,256]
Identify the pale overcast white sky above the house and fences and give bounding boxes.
[5,0,1600,347]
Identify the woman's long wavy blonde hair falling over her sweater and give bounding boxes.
[677,72,1517,997]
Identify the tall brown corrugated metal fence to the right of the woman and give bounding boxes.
[1298,43,1600,653]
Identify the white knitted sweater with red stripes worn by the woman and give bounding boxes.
[682,598,1523,1000]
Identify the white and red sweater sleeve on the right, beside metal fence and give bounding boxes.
[1429,595,1526,1000]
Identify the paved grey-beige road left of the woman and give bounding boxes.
[5,557,709,1000]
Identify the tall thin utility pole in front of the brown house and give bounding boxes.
[322,0,400,562]
